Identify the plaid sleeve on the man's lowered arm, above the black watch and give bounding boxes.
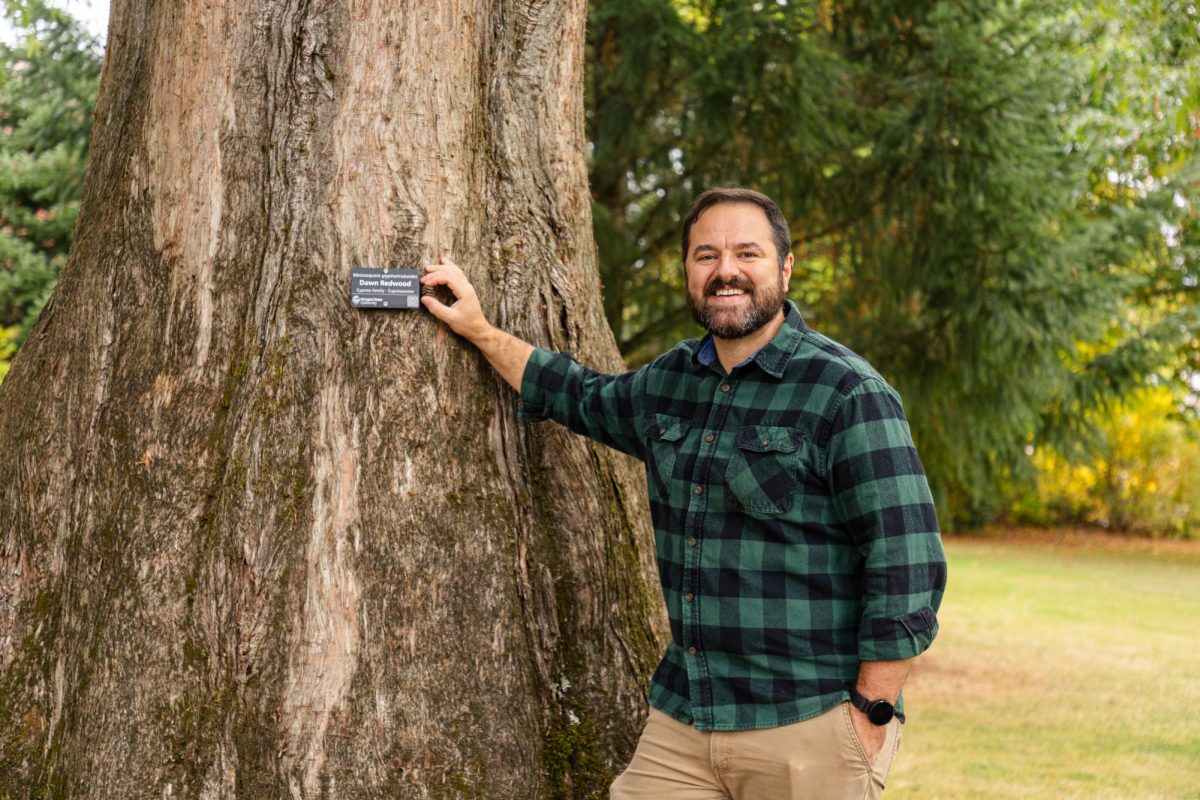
[826,378,946,661]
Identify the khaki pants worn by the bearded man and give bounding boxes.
[610,703,900,800]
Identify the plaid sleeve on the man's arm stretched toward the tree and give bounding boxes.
[517,348,646,458]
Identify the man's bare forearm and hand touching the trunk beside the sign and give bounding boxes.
[421,258,533,392]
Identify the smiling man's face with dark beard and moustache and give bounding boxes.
[684,203,792,339]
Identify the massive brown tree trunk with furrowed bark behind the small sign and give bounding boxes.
[0,0,664,799]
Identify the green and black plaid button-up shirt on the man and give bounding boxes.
[521,302,946,730]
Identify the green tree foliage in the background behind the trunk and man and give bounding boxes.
[0,0,1200,530]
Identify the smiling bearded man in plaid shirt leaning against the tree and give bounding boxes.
[421,188,946,800]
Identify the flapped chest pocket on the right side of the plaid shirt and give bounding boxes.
[725,425,805,515]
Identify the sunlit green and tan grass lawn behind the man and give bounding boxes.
[884,531,1200,800]
